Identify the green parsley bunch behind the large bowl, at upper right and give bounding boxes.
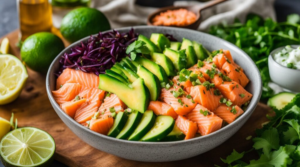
[209,14,300,99]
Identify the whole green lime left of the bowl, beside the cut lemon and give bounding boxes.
[21,32,65,73]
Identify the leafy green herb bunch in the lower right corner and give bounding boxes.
[221,94,300,167]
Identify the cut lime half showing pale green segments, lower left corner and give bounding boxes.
[0,127,55,167]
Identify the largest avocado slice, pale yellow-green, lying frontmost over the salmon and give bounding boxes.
[99,74,150,113]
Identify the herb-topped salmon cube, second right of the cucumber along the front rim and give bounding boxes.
[187,104,223,136]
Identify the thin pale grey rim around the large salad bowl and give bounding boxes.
[46,26,262,145]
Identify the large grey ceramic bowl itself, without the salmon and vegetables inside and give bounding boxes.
[46,26,262,162]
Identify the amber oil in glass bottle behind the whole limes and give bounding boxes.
[18,0,52,41]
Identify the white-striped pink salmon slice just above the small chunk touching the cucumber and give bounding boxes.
[74,88,105,123]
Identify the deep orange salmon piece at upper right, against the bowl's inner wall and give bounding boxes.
[222,62,249,87]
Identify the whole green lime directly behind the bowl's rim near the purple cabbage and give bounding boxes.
[60,7,110,42]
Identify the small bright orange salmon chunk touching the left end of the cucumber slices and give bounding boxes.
[90,116,114,135]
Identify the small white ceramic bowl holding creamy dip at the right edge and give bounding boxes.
[268,45,300,92]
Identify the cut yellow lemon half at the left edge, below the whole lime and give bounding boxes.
[0,54,28,105]
